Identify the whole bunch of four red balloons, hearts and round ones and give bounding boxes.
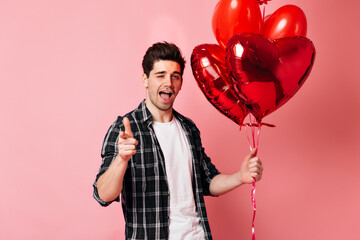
[191,0,315,125]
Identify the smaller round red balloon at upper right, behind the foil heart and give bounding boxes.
[263,5,307,40]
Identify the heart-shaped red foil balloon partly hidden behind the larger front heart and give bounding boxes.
[191,44,247,125]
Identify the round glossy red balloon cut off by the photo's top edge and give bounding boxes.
[212,0,262,49]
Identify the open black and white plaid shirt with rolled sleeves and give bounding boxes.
[93,101,219,240]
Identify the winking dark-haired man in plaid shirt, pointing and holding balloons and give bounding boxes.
[94,42,263,240]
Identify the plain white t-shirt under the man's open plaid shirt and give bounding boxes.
[153,117,205,240]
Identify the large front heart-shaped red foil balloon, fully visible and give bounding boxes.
[226,33,315,122]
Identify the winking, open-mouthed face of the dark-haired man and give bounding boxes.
[143,60,182,111]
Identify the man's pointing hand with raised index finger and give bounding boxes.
[118,117,138,161]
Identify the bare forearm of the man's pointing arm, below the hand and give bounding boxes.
[97,156,128,202]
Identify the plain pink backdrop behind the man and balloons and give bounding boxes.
[0,0,360,240]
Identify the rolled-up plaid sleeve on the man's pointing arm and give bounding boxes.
[93,117,122,207]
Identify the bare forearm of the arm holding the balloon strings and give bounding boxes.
[210,172,243,196]
